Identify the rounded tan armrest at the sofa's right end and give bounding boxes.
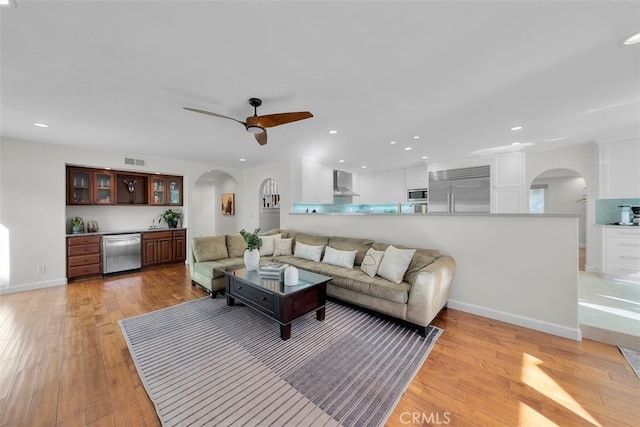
[407,255,456,326]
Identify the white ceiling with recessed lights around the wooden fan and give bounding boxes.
[0,0,640,170]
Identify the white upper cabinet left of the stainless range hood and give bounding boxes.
[292,159,333,203]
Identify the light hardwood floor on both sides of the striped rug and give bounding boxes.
[0,265,640,427]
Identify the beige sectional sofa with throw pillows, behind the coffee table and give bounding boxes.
[189,229,455,335]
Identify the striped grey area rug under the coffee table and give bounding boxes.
[120,298,442,426]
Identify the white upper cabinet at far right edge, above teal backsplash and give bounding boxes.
[600,140,640,199]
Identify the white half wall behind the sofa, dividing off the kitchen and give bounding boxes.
[281,214,581,340]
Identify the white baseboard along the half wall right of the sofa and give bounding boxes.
[447,300,582,341]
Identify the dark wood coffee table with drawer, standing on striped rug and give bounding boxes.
[222,267,331,340]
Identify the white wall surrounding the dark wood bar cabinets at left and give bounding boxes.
[0,138,241,294]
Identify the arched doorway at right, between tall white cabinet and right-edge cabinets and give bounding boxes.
[529,169,587,270]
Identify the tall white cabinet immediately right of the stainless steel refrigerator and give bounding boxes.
[491,151,528,213]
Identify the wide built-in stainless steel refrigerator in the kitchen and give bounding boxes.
[429,166,491,213]
